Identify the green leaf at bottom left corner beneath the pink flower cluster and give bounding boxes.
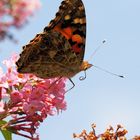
[0,120,12,140]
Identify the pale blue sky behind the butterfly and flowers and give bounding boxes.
[0,0,140,140]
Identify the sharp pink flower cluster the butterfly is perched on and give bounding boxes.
[0,55,66,139]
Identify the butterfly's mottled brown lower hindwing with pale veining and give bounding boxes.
[16,30,82,78]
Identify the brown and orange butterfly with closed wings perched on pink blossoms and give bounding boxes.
[16,0,92,83]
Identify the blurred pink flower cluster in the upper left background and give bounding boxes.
[0,0,41,40]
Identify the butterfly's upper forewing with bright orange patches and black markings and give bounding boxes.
[44,0,86,65]
